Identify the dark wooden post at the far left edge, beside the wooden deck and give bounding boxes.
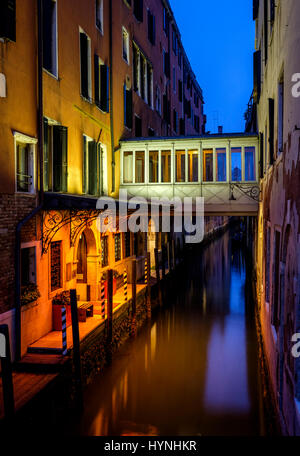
[0,325,15,420]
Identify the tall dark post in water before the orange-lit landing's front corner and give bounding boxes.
[70,290,83,409]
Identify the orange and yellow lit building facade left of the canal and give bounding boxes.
[0,0,205,358]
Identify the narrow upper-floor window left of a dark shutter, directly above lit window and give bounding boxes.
[80,31,92,101]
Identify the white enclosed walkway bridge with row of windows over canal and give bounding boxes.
[120,133,260,216]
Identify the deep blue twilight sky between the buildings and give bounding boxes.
[170,0,255,133]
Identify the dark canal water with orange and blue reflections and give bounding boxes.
[69,232,264,436]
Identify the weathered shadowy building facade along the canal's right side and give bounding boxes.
[254,0,300,435]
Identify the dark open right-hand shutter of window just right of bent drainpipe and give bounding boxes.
[53,125,68,192]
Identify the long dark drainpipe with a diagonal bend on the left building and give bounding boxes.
[15,0,44,361]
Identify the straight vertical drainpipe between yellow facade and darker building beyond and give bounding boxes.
[109,0,116,193]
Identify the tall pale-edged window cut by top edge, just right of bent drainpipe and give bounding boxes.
[43,0,57,76]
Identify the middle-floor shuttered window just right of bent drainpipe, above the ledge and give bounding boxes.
[44,119,68,192]
